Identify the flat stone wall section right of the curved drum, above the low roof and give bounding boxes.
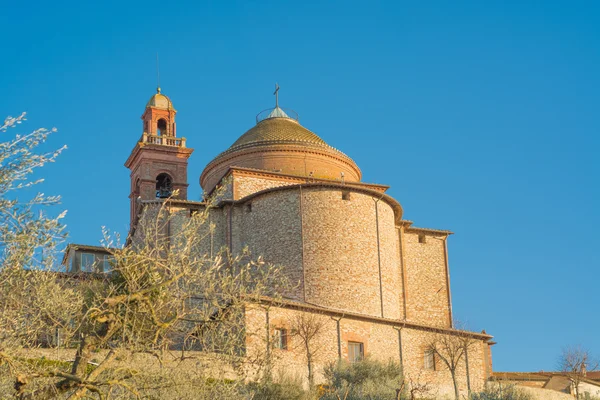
[401,228,451,327]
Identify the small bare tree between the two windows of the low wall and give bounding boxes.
[290,313,325,388]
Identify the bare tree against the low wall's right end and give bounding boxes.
[427,322,476,400]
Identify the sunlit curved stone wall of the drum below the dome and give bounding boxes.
[302,188,401,318]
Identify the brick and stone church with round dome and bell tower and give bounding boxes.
[63,88,494,394]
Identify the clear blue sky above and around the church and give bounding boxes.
[0,1,600,371]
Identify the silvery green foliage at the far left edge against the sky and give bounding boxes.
[0,113,82,390]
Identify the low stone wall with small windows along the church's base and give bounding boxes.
[246,305,487,398]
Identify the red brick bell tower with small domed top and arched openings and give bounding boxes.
[125,87,194,225]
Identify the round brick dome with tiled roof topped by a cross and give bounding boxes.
[200,114,361,192]
